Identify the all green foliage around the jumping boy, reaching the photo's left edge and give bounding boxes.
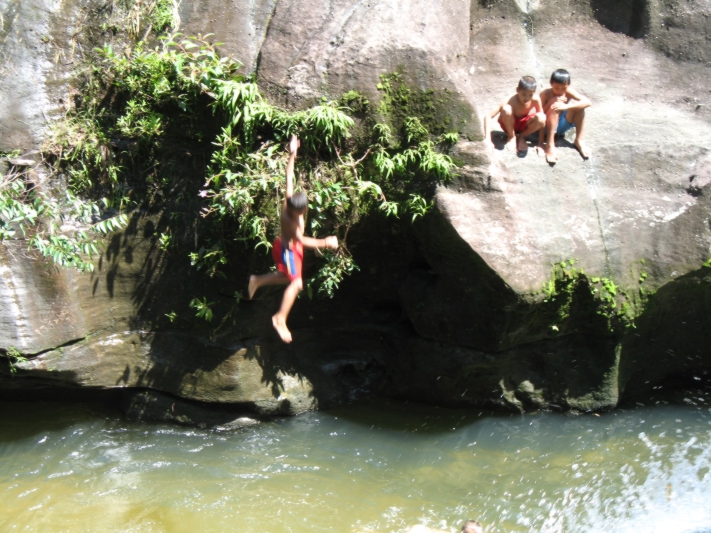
[0,0,457,320]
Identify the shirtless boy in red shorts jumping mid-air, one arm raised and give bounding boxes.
[249,135,338,342]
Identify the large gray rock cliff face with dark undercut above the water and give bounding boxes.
[0,0,711,414]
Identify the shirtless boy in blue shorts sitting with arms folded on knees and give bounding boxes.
[539,68,591,163]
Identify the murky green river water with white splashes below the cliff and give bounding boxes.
[0,398,711,533]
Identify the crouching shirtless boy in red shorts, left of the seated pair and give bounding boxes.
[484,76,546,152]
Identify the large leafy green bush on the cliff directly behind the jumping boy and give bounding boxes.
[40,33,456,296]
